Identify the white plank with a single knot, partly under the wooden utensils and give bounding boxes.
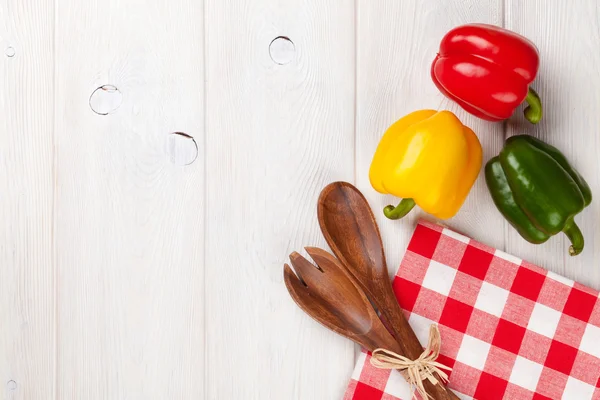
[205,0,355,400]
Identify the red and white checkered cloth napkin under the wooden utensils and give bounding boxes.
[344,222,600,400]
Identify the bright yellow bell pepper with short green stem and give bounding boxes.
[369,110,482,219]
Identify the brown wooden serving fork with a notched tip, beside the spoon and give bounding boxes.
[283,247,459,400]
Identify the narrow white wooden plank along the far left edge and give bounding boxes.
[0,0,55,400]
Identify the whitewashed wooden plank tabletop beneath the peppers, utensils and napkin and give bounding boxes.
[0,0,600,400]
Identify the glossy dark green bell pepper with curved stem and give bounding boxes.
[485,135,592,256]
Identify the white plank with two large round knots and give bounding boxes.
[55,0,204,400]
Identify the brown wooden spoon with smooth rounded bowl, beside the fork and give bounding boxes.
[318,182,458,399]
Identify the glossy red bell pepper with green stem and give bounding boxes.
[431,24,542,124]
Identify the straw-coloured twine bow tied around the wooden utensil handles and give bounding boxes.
[371,325,452,399]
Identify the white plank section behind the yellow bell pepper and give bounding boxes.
[356,0,505,274]
